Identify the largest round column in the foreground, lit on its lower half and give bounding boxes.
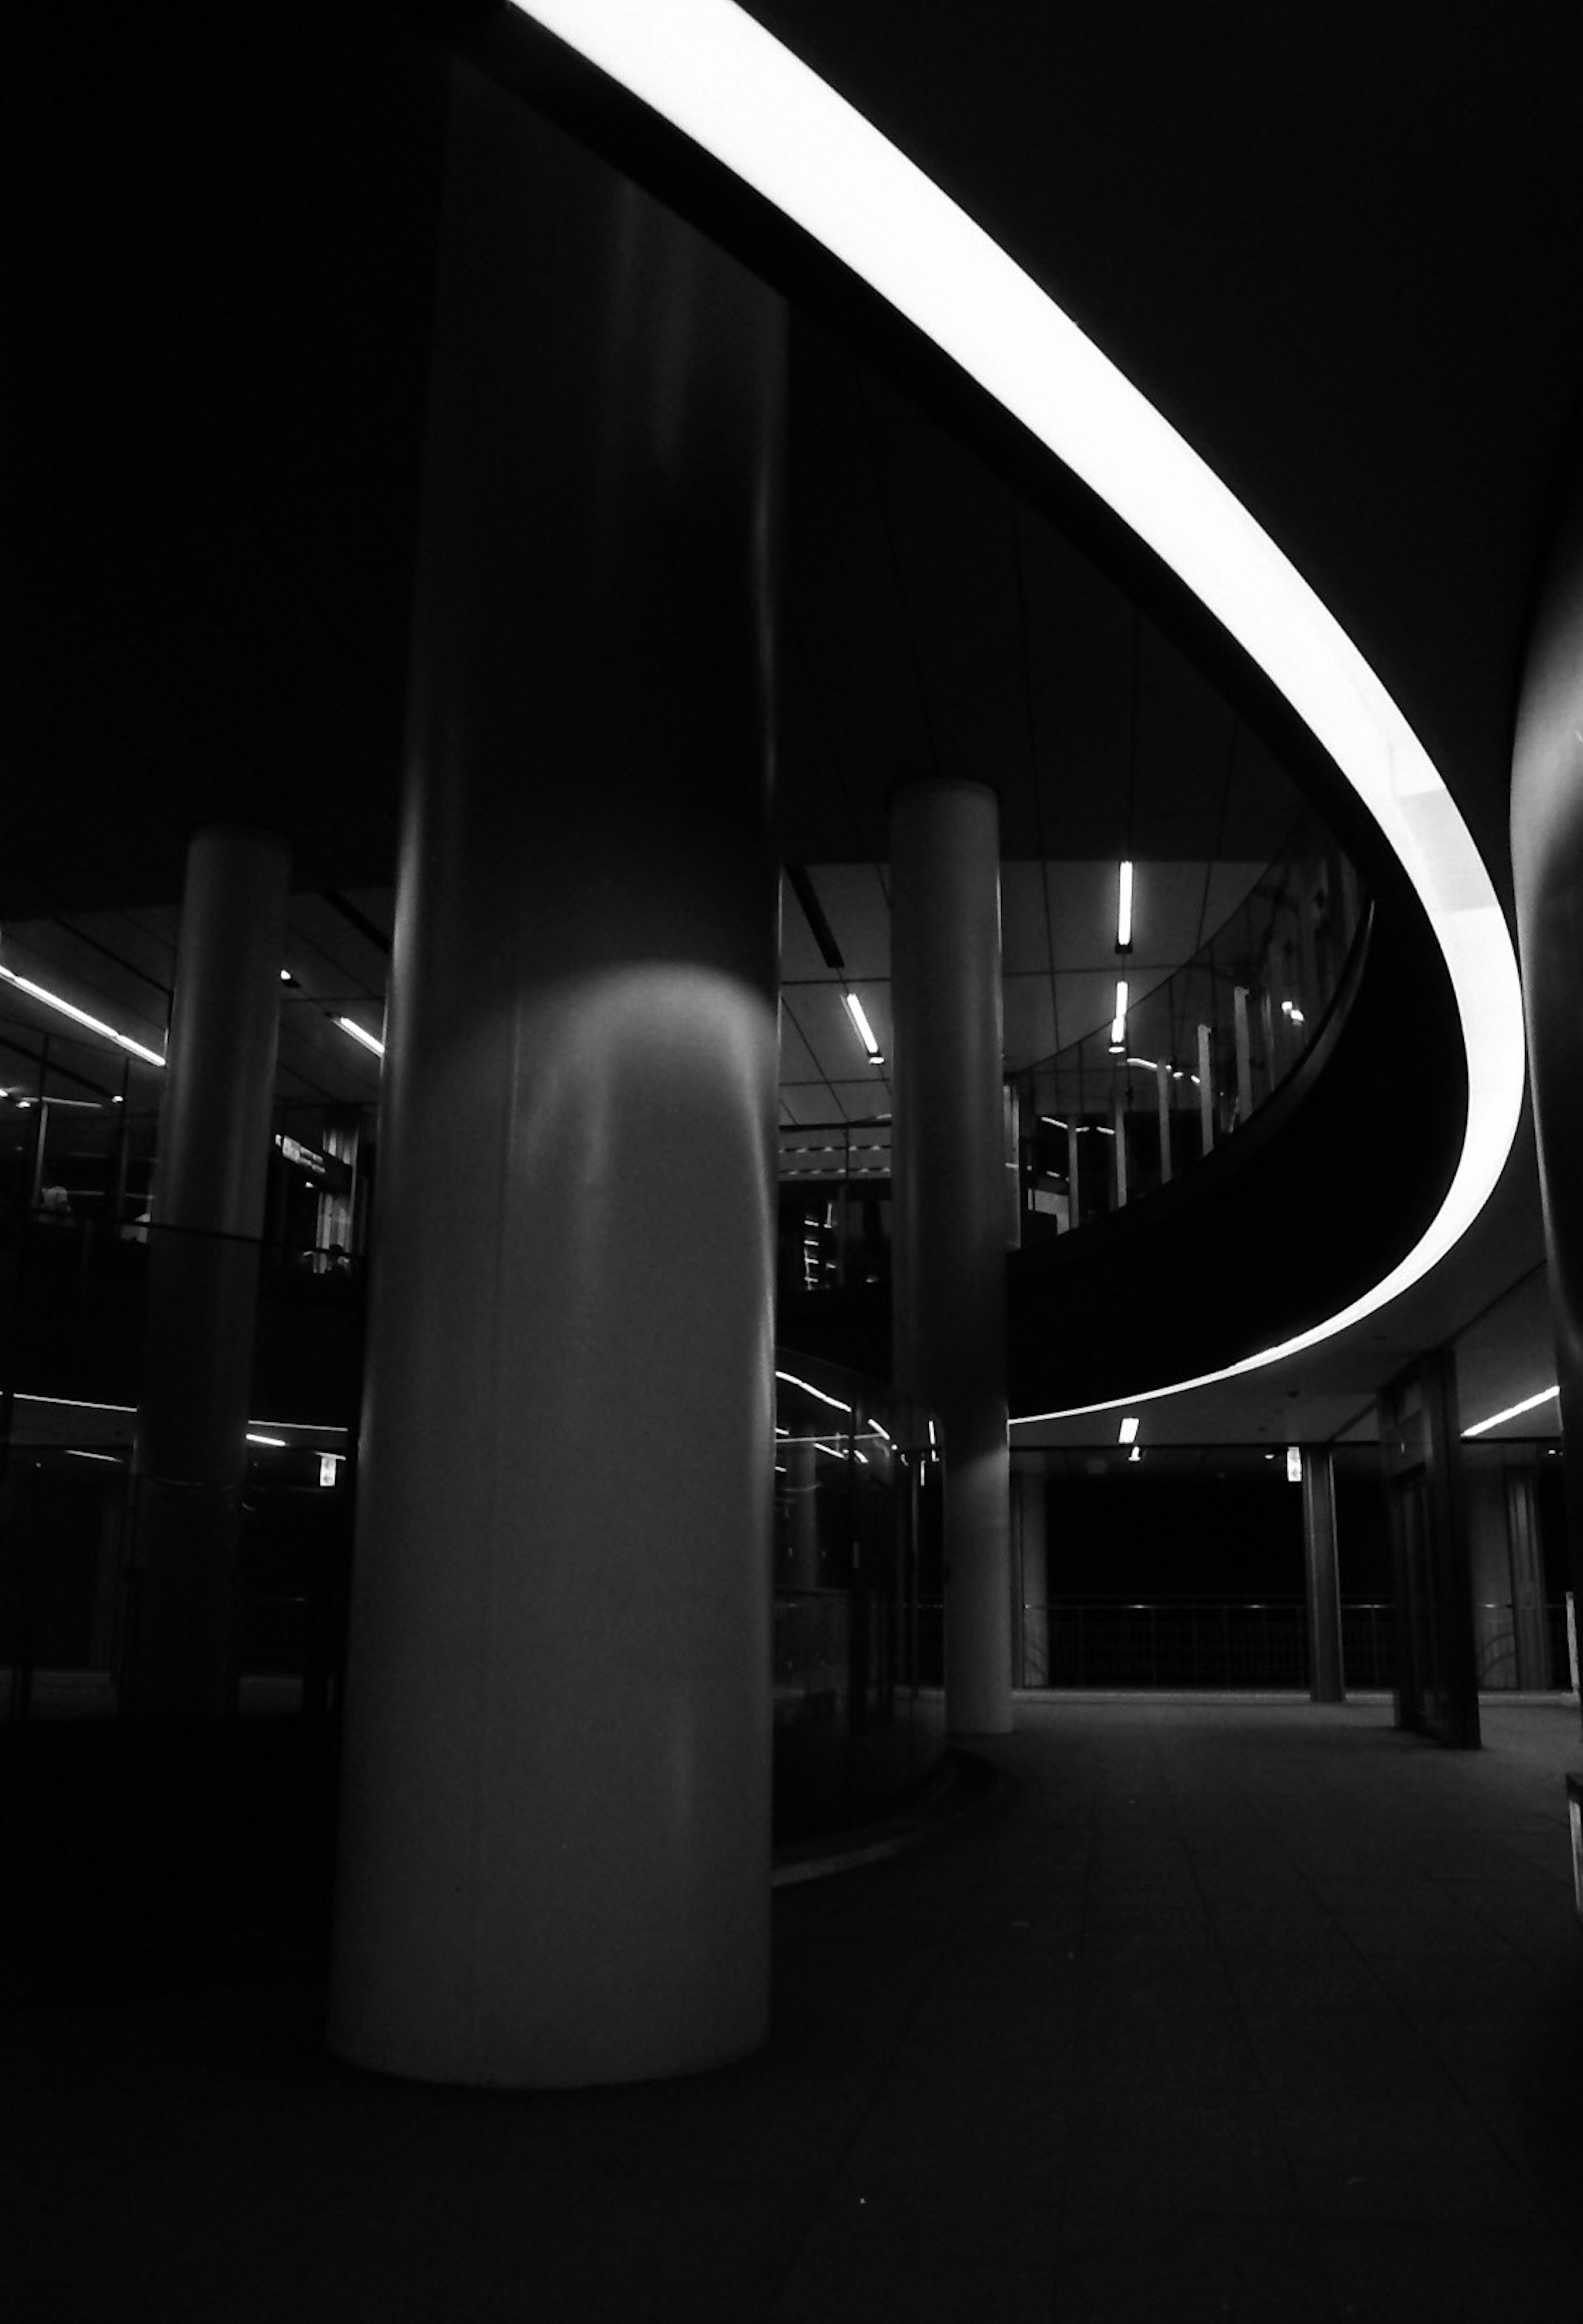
[330,68,783,2085]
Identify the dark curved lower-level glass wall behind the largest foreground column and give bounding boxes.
[0,1283,942,1836]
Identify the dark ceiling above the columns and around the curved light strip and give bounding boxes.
[15,0,1583,1441]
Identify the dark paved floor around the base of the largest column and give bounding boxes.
[0,1699,1583,2324]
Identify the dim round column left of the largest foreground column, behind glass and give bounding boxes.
[121,823,291,1717]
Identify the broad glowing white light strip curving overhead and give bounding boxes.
[516,0,1525,1420]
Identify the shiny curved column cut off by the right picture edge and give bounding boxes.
[1511,453,1583,1738]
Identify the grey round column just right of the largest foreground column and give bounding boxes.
[890,781,1011,1734]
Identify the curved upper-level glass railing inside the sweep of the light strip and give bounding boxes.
[1007,818,1367,1241]
